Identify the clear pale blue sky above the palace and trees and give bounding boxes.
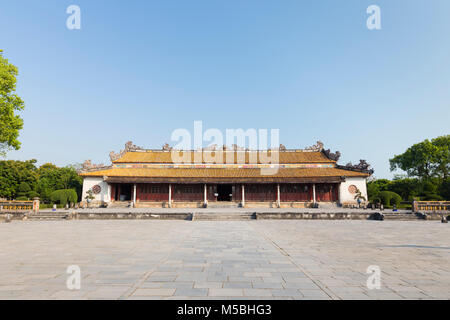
[0,0,450,178]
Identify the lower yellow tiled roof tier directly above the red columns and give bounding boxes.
[81,168,369,179]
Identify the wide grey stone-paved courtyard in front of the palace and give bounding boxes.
[0,220,450,300]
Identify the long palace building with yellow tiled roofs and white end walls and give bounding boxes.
[80,142,373,207]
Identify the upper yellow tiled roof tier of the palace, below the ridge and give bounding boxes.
[113,150,335,163]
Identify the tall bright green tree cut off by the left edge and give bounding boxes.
[0,50,25,156]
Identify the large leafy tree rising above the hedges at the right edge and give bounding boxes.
[389,135,450,179]
